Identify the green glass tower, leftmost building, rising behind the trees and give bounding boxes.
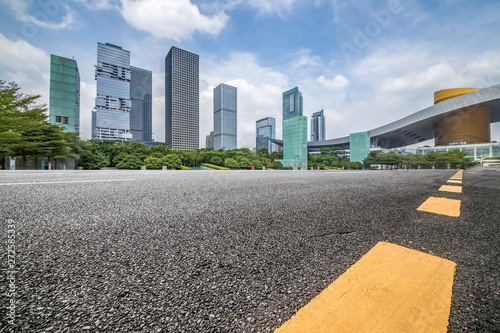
[49,54,80,132]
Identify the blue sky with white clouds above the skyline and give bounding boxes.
[0,0,500,148]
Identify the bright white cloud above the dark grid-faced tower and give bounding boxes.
[120,0,229,41]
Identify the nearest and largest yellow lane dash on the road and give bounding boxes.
[275,242,456,333]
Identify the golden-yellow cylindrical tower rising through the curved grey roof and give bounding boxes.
[434,88,491,146]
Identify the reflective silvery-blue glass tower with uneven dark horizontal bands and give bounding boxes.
[92,43,132,140]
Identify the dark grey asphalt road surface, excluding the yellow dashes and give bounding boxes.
[0,169,500,332]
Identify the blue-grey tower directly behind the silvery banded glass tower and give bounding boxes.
[130,66,153,141]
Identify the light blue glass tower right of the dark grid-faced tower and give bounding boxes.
[214,83,238,150]
